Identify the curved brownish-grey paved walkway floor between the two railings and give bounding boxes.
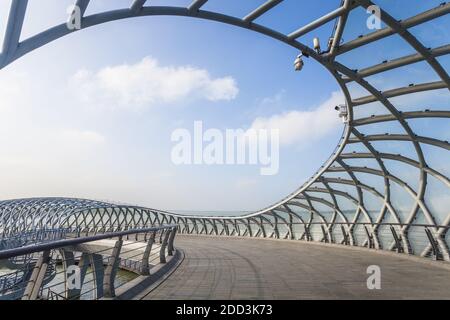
[146,236,450,300]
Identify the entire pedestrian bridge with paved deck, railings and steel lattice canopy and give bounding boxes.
[0,0,450,299]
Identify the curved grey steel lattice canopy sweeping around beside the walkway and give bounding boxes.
[0,0,450,260]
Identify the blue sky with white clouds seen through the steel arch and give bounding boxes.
[0,0,450,215]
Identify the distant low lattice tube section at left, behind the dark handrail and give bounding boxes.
[0,198,179,239]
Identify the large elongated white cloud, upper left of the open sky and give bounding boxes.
[70,57,239,108]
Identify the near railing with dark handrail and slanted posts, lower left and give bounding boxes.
[0,224,177,300]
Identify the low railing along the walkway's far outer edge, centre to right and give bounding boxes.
[177,220,450,261]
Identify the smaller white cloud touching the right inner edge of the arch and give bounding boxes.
[250,92,345,145]
